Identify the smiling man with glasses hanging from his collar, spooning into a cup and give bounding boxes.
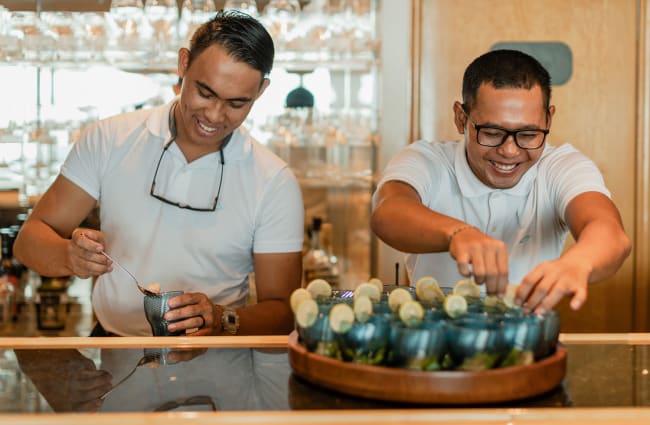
[15,11,303,336]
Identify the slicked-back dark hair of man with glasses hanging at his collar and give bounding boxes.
[188,10,275,77]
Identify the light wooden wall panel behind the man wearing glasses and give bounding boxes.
[419,0,636,331]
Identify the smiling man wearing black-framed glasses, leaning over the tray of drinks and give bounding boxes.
[372,50,630,314]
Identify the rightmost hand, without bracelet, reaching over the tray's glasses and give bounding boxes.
[515,258,591,314]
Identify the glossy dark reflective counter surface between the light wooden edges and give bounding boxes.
[0,344,650,413]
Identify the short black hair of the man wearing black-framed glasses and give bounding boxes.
[463,49,551,112]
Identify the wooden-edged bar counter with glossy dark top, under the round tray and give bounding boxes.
[0,334,650,425]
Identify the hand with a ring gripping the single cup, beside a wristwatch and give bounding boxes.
[164,292,222,336]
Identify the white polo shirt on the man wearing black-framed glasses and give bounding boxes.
[373,141,610,290]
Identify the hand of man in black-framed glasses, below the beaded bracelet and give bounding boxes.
[449,225,508,295]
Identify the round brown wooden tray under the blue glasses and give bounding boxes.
[289,331,566,404]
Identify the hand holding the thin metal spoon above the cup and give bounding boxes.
[67,228,113,279]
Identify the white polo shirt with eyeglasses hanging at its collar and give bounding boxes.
[61,102,303,335]
